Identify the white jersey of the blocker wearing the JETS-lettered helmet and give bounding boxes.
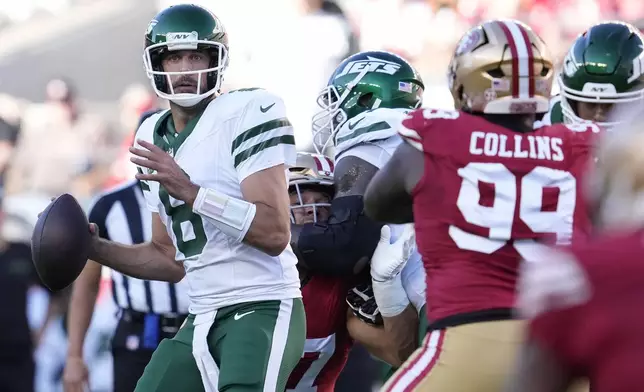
[335,108,426,311]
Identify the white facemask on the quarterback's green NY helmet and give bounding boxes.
[143,33,228,107]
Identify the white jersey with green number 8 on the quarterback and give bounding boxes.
[137,89,301,314]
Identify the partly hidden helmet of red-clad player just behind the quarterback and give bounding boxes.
[288,152,334,223]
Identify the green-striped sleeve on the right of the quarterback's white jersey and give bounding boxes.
[231,90,297,183]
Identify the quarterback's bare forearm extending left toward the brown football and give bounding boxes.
[90,239,185,283]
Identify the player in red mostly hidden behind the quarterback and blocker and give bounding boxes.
[286,153,353,392]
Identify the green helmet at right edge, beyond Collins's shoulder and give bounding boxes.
[558,22,644,127]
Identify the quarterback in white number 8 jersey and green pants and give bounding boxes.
[83,4,305,392]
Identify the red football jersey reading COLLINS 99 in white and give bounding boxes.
[400,109,599,321]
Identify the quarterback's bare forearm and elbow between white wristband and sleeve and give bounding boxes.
[244,203,291,256]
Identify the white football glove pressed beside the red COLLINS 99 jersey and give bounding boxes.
[371,225,416,317]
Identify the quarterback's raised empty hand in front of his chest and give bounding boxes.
[130,140,199,205]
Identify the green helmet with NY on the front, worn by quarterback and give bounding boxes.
[143,4,228,107]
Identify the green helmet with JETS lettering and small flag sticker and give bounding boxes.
[313,51,425,153]
